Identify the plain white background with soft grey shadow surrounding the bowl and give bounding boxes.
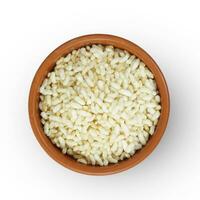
[0,0,200,200]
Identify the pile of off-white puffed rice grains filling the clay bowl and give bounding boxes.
[39,45,161,166]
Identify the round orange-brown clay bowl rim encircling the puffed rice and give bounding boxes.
[28,34,170,175]
